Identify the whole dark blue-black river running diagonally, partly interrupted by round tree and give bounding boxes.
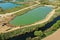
[7,16,60,40]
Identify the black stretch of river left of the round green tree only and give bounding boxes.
[8,31,35,40]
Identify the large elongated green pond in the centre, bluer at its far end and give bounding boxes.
[10,6,52,26]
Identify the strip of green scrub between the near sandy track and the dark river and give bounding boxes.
[0,25,43,40]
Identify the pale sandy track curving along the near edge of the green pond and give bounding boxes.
[3,9,55,33]
